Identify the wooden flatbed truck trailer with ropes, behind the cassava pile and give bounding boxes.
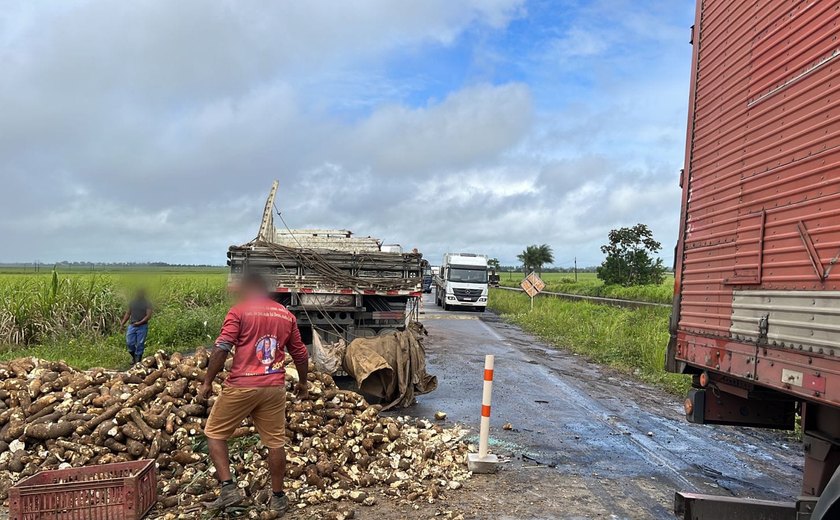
[227,182,423,344]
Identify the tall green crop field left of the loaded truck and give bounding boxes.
[0,269,228,368]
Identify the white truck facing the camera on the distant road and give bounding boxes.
[435,253,488,312]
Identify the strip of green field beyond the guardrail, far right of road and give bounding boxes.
[501,272,674,303]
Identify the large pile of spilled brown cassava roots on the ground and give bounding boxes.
[0,349,469,520]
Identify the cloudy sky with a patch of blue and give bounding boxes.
[0,0,694,265]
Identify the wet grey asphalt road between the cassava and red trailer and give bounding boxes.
[407,295,802,519]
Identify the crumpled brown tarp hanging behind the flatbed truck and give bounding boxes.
[344,324,437,410]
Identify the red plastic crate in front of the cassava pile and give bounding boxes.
[9,460,157,520]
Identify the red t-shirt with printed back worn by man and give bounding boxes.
[216,297,309,387]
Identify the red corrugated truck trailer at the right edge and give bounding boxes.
[667,0,840,519]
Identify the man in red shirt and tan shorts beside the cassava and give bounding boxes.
[200,273,309,515]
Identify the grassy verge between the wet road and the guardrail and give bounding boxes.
[490,289,690,393]
